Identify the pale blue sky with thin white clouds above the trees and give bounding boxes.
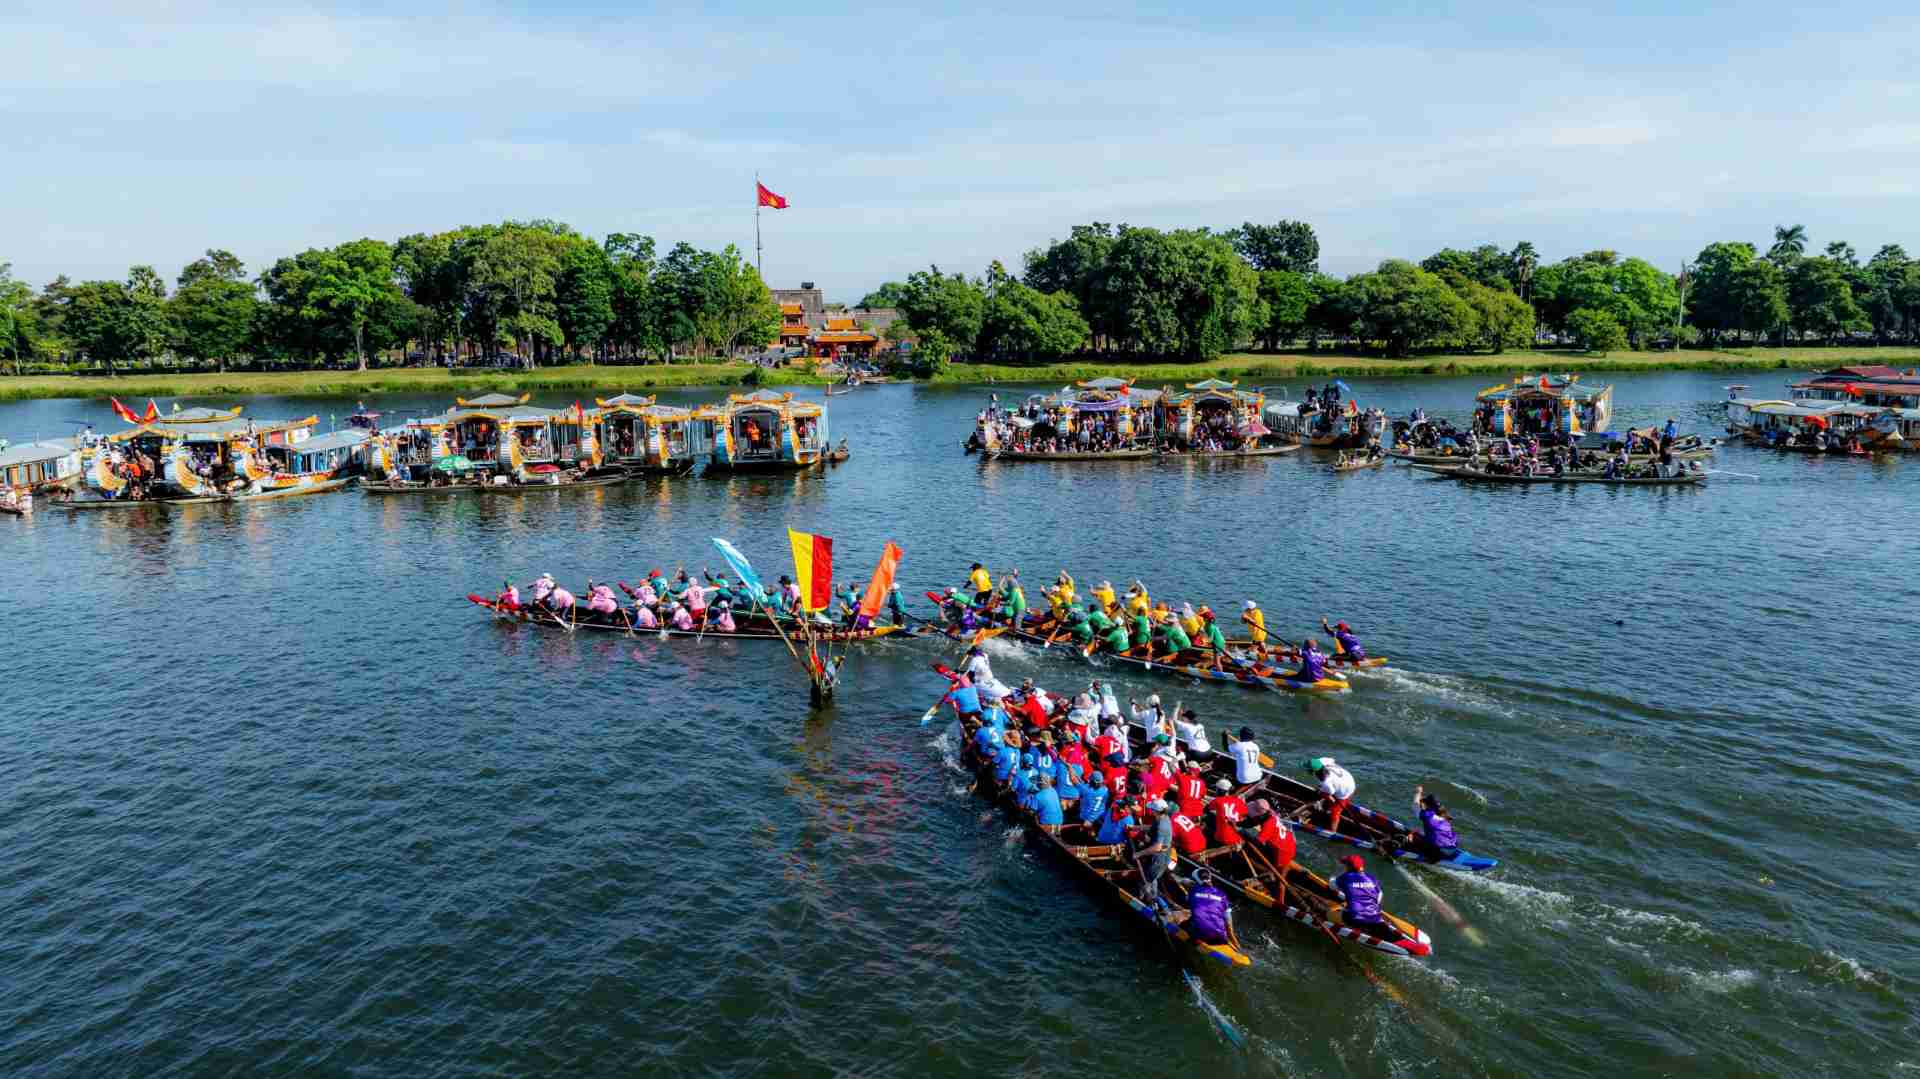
[0,0,1920,300]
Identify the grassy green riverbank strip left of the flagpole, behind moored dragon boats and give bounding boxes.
[0,363,826,401]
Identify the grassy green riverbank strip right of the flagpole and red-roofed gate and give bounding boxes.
[921,346,1920,386]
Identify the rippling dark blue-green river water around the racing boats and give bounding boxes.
[0,372,1920,1077]
